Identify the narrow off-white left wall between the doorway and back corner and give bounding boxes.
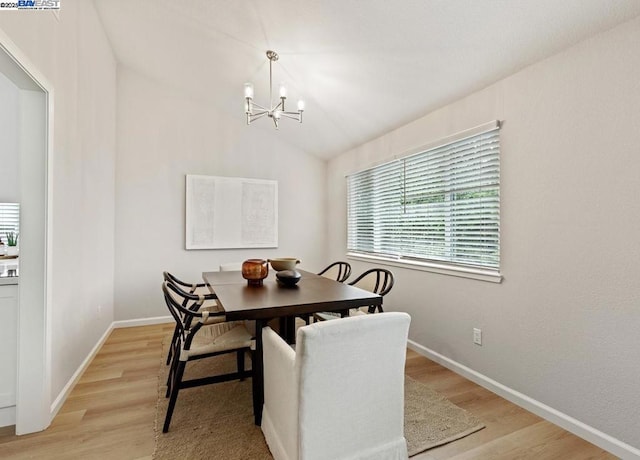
[0,0,116,401]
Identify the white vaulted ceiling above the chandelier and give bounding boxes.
[95,0,640,158]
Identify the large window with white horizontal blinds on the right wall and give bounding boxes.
[347,121,500,274]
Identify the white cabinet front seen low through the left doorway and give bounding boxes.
[0,284,18,426]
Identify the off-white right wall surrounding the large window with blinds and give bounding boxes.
[327,19,640,448]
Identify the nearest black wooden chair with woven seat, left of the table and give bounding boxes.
[162,281,255,433]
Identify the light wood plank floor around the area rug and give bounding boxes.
[0,325,615,460]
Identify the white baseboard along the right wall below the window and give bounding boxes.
[408,340,640,460]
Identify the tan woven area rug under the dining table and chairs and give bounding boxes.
[153,340,484,460]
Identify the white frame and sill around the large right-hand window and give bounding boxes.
[346,120,502,283]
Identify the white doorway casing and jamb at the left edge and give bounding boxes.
[0,30,53,434]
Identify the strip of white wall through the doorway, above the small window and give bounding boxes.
[0,72,20,201]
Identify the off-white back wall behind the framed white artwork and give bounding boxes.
[115,66,328,320]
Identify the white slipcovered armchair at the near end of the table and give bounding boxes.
[262,312,411,460]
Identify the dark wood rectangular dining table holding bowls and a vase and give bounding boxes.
[202,270,382,426]
